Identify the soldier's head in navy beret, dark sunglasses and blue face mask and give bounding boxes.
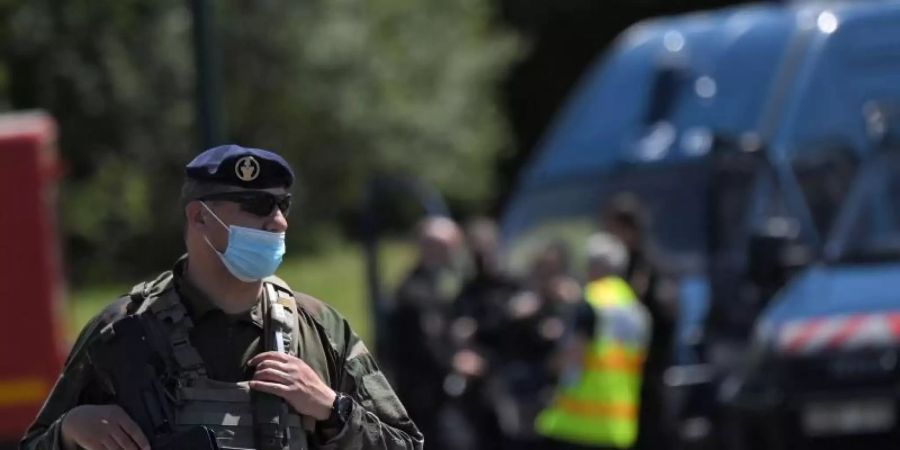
[181,145,294,282]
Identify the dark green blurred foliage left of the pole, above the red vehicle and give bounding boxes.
[0,0,193,284]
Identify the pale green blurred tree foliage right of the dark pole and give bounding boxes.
[223,0,517,218]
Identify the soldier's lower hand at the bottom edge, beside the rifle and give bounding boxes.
[62,405,150,450]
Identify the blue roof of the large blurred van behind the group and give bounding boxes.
[503,1,900,246]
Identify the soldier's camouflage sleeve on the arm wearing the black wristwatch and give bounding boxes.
[319,322,424,450]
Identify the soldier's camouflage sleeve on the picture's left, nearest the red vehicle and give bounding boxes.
[19,298,125,450]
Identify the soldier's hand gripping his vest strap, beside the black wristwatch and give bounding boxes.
[248,352,335,420]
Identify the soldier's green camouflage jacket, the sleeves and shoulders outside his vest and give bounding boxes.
[20,264,424,450]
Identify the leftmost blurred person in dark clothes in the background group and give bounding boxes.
[386,217,464,449]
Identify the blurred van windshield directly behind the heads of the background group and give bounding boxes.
[505,161,708,282]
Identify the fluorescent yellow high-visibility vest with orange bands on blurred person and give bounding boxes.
[535,277,650,448]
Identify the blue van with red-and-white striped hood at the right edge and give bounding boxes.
[720,125,900,449]
